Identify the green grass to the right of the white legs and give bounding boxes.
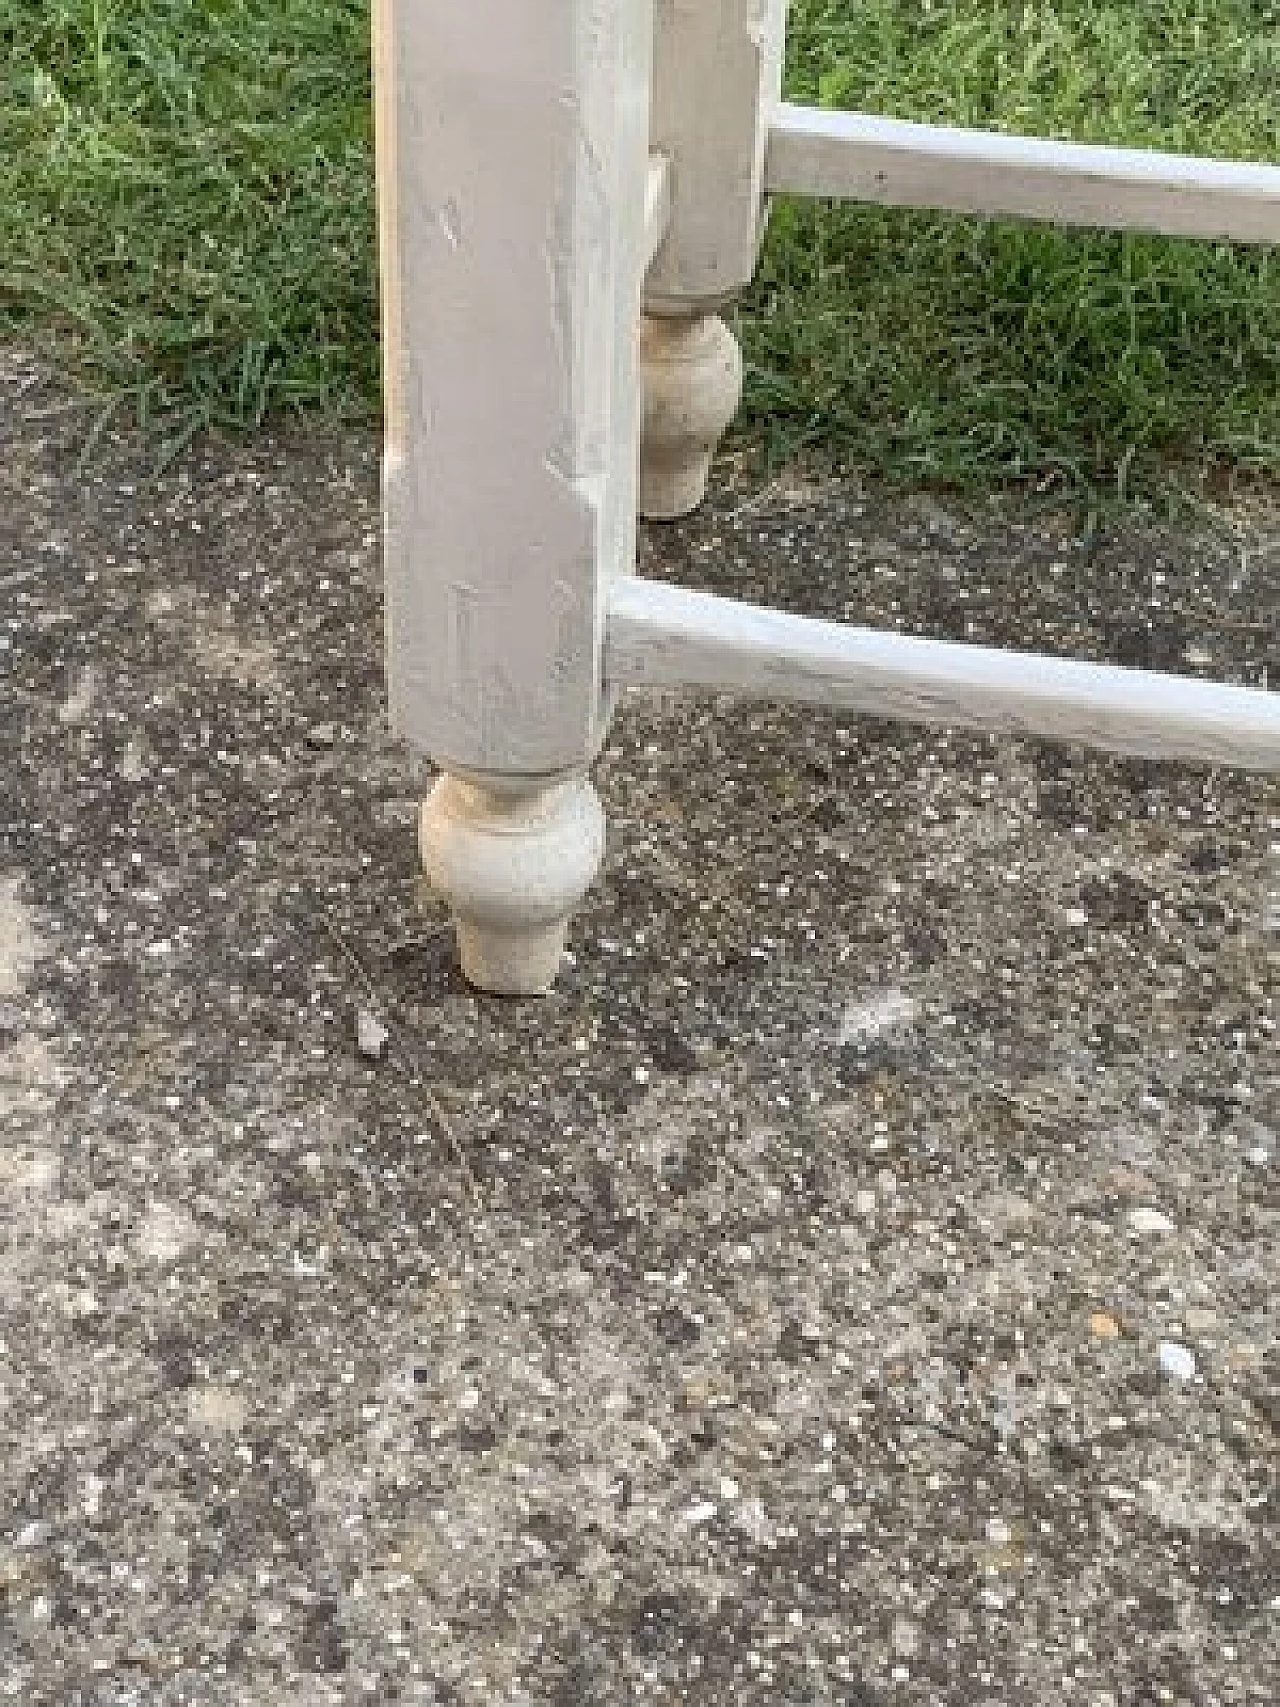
[742,0,1280,495]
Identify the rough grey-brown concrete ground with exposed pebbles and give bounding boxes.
[0,352,1280,1707]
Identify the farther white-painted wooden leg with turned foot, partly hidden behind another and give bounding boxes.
[640,0,787,521]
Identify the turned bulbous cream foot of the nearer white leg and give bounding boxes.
[418,775,604,995]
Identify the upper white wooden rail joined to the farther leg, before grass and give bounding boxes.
[765,104,1280,242]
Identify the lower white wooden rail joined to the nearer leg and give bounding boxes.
[604,577,1280,772]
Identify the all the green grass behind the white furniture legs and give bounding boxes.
[0,0,1280,493]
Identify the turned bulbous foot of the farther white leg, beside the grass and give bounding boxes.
[640,314,742,521]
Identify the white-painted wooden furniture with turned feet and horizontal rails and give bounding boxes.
[374,0,1280,993]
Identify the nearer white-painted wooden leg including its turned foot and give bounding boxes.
[374,0,651,995]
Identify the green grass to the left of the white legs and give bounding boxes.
[0,0,379,447]
